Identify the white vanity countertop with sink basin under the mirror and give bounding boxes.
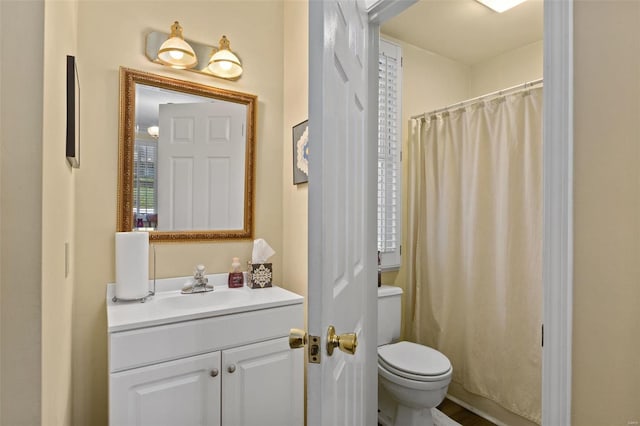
[106,274,304,333]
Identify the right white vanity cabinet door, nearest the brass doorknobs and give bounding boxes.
[222,337,304,426]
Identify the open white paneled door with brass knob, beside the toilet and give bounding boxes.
[307,0,377,426]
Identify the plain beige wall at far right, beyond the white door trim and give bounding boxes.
[572,1,640,426]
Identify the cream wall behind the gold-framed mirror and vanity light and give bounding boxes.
[73,0,283,425]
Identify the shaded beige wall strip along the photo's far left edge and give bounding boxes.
[0,1,44,426]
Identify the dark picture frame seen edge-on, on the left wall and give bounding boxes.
[65,55,80,169]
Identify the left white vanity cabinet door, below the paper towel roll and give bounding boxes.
[109,352,221,426]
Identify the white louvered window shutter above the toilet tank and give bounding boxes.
[378,39,402,268]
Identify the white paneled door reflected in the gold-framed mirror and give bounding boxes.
[157,102,247,231]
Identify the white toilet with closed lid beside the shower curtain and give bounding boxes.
[378,285,453,426]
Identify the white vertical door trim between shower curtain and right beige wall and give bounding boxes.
[542,0,573,425]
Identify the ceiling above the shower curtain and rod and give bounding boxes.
[381,0,543,65]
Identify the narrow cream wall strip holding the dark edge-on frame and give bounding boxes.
[42,1,78,426]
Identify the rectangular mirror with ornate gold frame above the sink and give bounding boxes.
[116,67,258,242]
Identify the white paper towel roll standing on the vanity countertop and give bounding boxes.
[116,232,149,299]
